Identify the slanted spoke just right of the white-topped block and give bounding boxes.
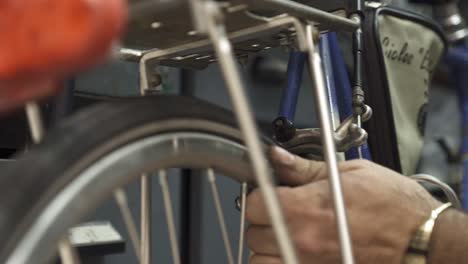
[114,188,141,261]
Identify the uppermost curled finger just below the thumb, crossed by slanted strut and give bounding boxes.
[245,187,295,225]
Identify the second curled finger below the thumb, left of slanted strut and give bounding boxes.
[246,225,280,256]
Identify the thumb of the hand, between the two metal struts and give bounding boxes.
[270,146,327,186]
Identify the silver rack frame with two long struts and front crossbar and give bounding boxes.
[132,0,362,264]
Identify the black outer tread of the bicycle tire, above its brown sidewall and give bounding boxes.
[0,95,252,263]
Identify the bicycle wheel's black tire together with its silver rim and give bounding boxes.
[0,96,271,264]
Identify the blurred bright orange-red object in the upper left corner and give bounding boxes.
[0,0,127,112]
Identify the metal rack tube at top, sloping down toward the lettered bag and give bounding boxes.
[249,0,359,32]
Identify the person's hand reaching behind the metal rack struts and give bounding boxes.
[246,147,440,264]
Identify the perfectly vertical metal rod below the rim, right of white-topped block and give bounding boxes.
[140,174,152,264]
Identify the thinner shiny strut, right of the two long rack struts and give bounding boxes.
[306,25,354,264]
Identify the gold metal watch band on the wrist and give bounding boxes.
[403,203,452,264]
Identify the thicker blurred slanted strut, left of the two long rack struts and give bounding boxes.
[203,1,299,264]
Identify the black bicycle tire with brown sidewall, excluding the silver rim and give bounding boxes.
[0,96,272,263]
